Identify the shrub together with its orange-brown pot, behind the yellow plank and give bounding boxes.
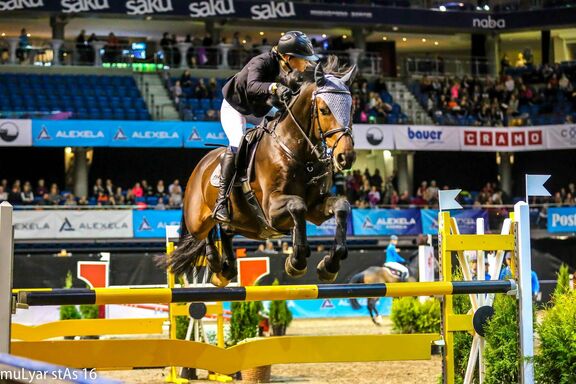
[230,301,272,383]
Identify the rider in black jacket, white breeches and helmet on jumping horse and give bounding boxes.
[212,31,318,223]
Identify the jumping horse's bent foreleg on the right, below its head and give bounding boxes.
[316,197,351,282]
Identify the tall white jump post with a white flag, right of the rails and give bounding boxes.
[514,201,534,384]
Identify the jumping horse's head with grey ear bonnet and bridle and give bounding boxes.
[312,64,357,171]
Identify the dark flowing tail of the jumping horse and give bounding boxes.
[161,214,206,276]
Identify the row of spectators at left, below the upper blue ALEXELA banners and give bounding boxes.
[0,179,184,209]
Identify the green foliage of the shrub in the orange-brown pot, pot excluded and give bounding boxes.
[229,301,264,345]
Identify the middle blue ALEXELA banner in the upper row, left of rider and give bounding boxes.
[110,121,183,148]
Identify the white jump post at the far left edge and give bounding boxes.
[0,201,14,353]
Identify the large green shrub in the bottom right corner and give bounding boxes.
[535,292,576,384]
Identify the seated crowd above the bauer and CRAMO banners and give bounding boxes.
[412,59,576,127]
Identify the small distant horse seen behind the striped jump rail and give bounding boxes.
[348,255,418,326]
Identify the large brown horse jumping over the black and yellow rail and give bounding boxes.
[168,57,357,287]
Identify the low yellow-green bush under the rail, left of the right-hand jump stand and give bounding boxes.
[391,297,440,333]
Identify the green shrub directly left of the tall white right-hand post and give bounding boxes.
[484,294,520,384]
